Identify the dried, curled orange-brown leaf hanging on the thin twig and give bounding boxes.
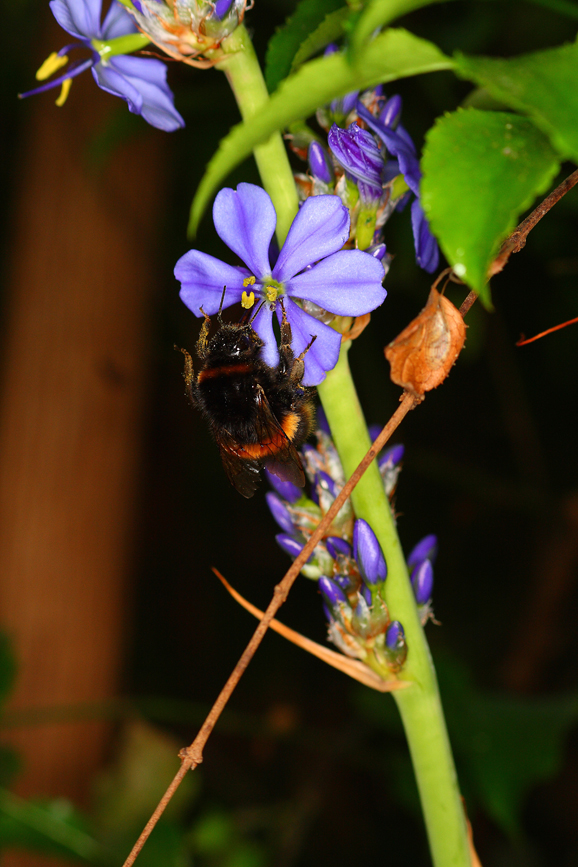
[385,287,466,397]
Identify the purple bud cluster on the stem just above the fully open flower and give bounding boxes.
[292,52,439,273]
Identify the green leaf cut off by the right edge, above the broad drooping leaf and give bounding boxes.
[456,43,578,162]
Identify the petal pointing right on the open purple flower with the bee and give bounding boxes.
[286,251,387,316]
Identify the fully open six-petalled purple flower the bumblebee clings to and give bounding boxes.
[175,184,386,385]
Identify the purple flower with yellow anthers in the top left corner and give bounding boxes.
[21,0,185,132]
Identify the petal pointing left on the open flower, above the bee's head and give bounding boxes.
[174,250,249,316]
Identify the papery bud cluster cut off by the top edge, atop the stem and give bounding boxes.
[122,0,247,67]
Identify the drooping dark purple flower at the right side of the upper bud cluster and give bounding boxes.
[357,97,439,274]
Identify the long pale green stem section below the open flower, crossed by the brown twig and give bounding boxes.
[318,344,471,867]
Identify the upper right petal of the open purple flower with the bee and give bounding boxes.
[273,196,349,283]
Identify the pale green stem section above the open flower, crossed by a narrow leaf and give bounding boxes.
[219,25,298,246]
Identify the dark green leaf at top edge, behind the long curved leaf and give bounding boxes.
[265,0,350,92]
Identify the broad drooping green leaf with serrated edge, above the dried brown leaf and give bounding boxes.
[421,108,559,307]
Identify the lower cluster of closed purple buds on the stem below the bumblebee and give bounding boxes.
[267,413,437,679]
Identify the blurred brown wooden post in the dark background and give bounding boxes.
[0,32,168,848]
